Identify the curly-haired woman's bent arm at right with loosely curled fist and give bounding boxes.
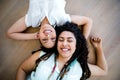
[88,37,108,76]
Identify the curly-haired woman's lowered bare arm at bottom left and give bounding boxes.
[16,51,40,80]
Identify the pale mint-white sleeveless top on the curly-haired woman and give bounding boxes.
[27,52,82,80]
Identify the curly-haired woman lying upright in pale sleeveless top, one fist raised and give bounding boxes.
[16,22,107,80]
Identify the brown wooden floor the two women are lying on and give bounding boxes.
[0,0,120,80]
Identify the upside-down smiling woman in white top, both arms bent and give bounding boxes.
[7,0,92,48]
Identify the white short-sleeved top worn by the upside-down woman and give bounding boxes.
[25,0,71,27]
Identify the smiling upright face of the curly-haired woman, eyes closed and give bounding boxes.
[57,31,76,59]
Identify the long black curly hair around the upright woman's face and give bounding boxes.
[55,22,91,80]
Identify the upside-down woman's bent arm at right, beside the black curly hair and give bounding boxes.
[71,15,92,39]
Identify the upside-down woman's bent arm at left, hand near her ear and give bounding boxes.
[7,16,38,40]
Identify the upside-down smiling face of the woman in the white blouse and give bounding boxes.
[39,24,56,48]
